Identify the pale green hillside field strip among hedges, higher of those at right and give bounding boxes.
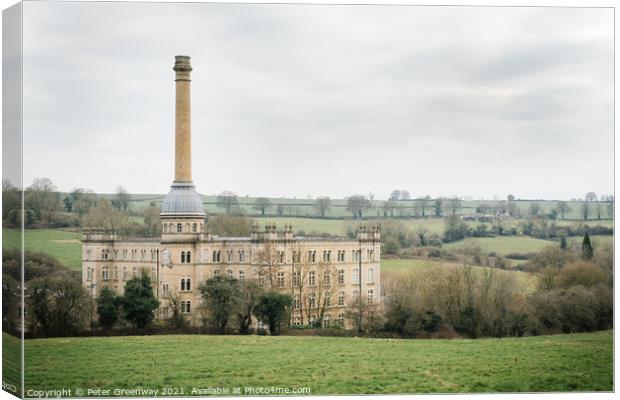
[443,236,558,254]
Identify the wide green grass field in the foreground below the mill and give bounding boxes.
[18,331,613,396]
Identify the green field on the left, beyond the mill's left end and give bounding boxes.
[2,229,82,269]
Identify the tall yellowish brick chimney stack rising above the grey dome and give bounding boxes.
[173,56,192,182]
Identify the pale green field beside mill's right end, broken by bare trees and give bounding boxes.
[381,259,537,293]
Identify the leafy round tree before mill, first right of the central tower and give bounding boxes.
[198,275,239,332]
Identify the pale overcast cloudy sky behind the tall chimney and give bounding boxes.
[17,2,613,199]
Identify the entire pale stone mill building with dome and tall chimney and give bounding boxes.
[82,56,381,327]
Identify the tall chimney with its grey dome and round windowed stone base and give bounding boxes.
[159,56,205,242]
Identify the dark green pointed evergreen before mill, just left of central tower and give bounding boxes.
[120,269,159,328]
